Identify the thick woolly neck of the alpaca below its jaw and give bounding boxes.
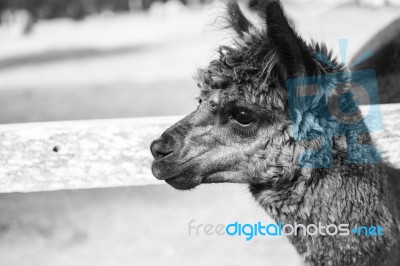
[250,138,399,265]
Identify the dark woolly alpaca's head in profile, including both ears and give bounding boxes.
[151,1,341,190]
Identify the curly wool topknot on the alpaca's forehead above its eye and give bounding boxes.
[196,35,284,109]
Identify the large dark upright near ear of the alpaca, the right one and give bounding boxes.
[265,1,312,78]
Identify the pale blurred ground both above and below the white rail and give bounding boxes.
[0,0,400,266]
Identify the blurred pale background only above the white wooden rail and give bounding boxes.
[0,0,400,123]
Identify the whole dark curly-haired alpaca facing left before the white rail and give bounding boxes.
[150,1,400,266]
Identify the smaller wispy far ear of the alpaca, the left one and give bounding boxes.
[227,1,253,37]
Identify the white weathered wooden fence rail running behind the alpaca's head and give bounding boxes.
[0,104,400,193]
